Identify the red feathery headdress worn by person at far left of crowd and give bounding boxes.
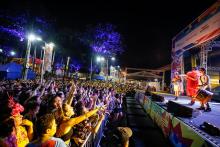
[8,95,24,116]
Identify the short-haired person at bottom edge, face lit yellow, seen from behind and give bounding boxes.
[27,114,67,147]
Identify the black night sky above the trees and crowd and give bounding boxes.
[0,0,215,68]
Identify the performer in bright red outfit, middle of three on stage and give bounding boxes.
[185,67,200,105]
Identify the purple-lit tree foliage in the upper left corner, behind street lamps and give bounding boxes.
[0,10,53,56]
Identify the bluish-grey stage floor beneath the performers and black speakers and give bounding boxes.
[156,93,220,143]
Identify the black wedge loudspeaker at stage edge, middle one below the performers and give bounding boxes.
[167,101,193,117]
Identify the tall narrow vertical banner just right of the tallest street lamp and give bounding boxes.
[44,45,53,72]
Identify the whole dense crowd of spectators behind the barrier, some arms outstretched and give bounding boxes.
[0,80,134,147]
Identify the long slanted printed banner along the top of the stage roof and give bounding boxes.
[172,1,220,53]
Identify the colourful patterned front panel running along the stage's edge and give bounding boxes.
[135,91,217,147]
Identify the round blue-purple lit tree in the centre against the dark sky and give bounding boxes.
[79,24,124,56]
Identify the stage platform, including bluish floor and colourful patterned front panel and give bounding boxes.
[135,91,220,147]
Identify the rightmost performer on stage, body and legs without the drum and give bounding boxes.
[199,68,211,111]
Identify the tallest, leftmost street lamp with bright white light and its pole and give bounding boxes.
[23,34,42,80]
